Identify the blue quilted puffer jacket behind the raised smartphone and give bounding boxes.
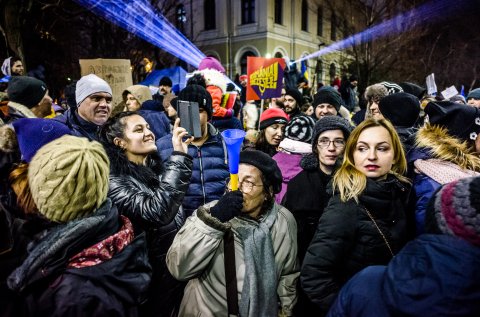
[156,124,229,217]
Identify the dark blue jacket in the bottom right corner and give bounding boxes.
[327,234,480,317]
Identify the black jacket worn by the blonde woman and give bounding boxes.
[300,175,408,315]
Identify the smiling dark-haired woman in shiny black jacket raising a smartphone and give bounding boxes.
[100,111,192,316]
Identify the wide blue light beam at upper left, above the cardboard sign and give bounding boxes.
[75,0,205,67]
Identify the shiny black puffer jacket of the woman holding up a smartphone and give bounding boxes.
[106,145,193,316]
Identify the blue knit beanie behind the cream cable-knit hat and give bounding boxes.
[12,118,71,163]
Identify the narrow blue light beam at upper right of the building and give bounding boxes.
[291,0,469,64]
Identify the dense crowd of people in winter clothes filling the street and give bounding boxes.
[0,53,480,317]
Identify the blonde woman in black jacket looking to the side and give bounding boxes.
[300,118,409,315]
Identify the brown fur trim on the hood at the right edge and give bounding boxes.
[415,124,480,172]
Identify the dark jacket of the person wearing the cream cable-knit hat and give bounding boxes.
[8,200,151,316]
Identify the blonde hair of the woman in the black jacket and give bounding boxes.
[333,118,409,202]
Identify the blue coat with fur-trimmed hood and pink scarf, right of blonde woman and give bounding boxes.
[407,125,480,235]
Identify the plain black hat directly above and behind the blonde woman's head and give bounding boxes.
[378,92,420,128]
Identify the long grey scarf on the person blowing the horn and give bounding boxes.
[230,204,278,317]
